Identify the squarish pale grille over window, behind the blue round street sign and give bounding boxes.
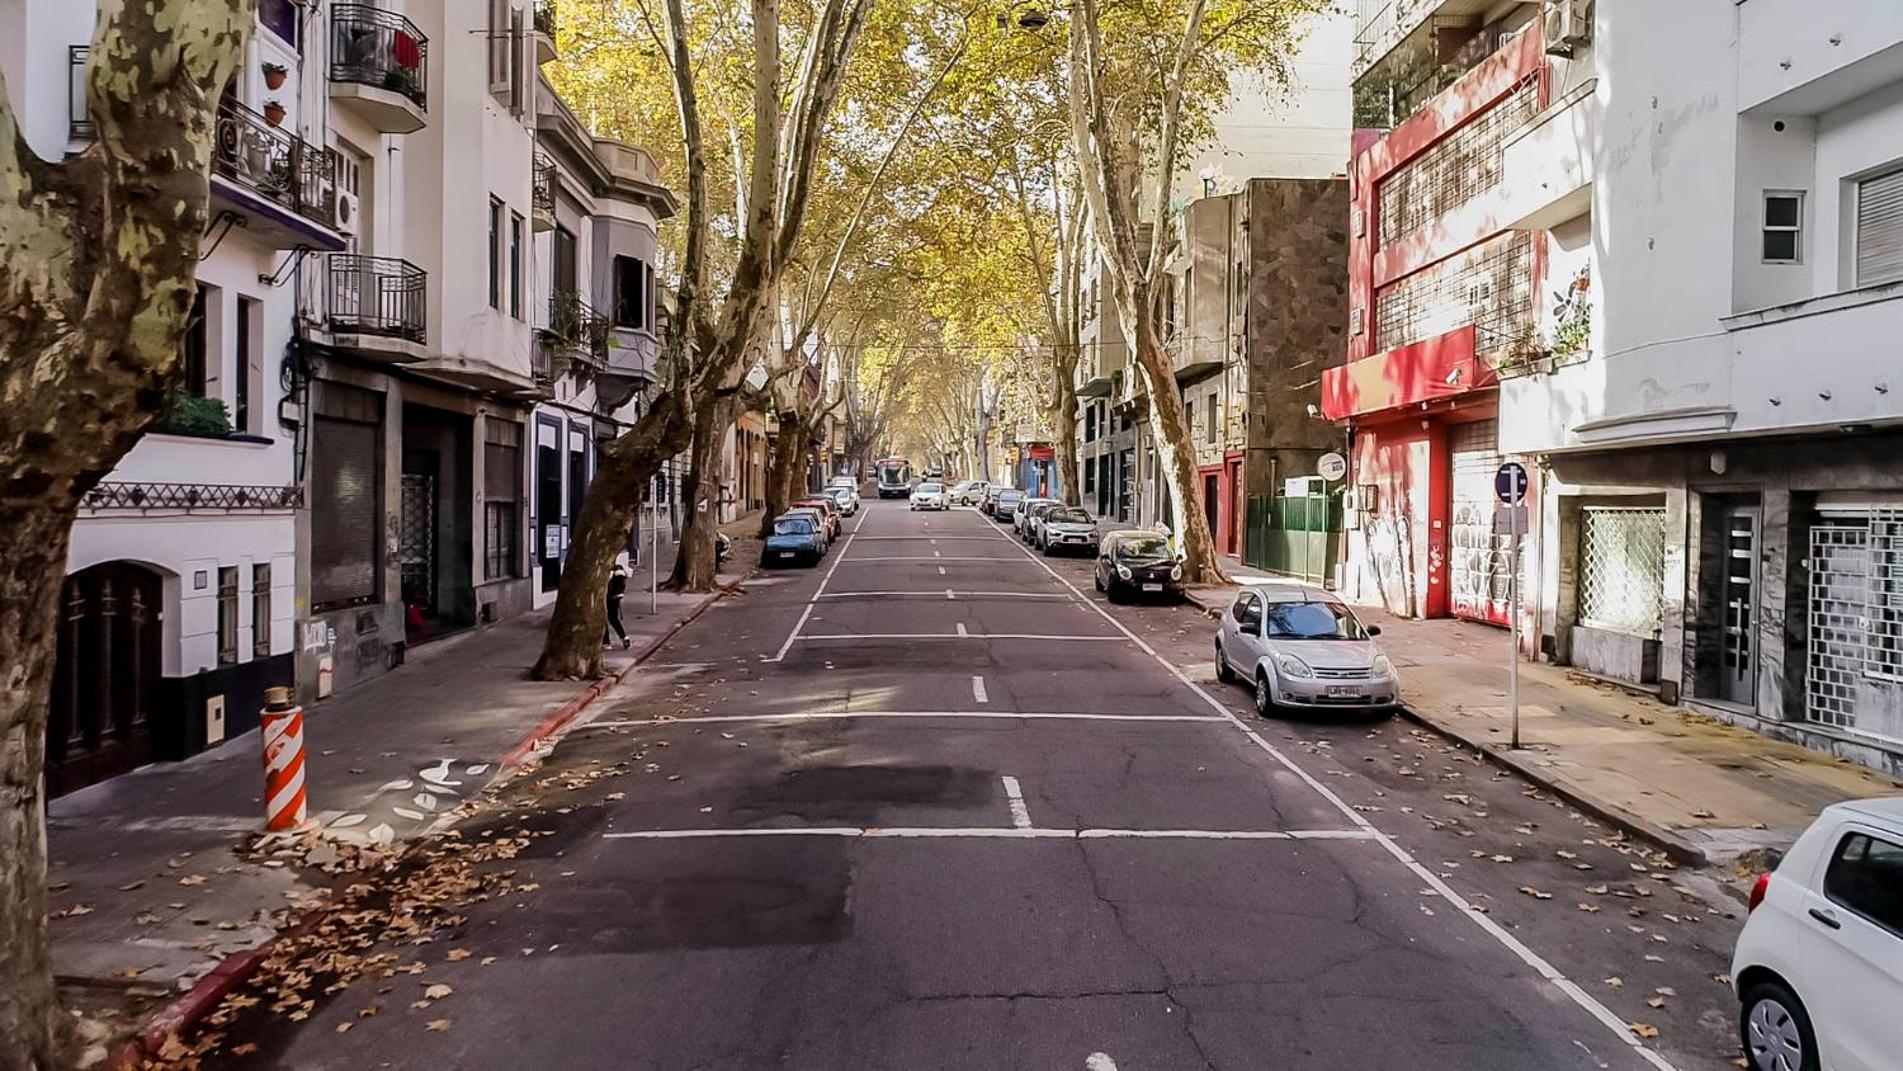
[1579,506,1665,635]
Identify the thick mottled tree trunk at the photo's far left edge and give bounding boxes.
[0,0,255,1069]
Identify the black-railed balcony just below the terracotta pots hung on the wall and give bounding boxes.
[211,99,343,249]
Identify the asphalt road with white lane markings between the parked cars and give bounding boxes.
[226,502,1736,1071]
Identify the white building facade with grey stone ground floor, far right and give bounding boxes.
[1500,0,1903,776]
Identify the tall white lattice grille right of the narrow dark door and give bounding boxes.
[1804,521,1871,729]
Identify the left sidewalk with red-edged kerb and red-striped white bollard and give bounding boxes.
[48,559,752,1019]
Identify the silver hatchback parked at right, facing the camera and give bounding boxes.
[1216,584,1401,717]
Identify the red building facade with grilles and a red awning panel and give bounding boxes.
[1321,29,1547,624]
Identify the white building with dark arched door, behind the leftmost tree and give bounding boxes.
[0,0,327,795]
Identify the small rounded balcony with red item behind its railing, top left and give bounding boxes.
[331,4,430,133]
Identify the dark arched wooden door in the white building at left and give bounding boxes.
[46,561,164,795]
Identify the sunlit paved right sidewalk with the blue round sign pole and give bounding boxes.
[1189,567,1903,864]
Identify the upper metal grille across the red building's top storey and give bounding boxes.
[1376,76,1540,245]
